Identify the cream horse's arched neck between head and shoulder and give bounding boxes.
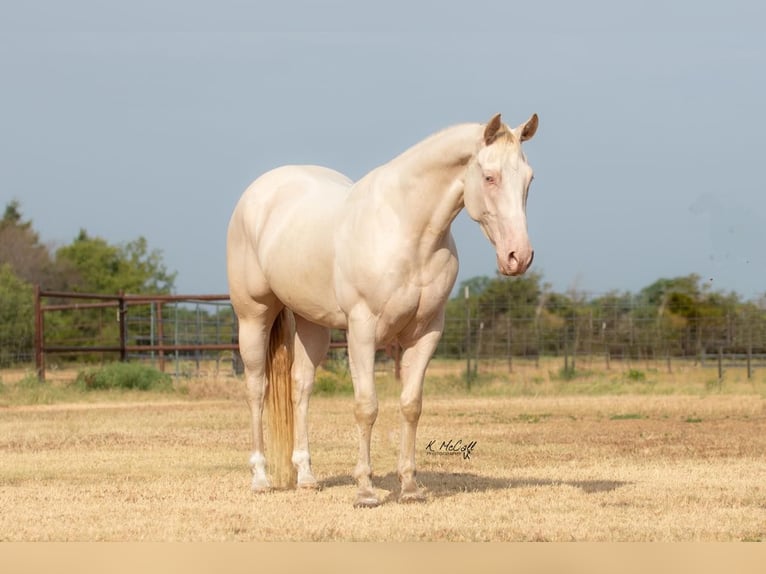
[380,124,482,242]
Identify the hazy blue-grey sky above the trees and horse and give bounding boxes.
[0,0,766,299]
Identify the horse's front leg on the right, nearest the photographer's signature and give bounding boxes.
[398,321,441,502]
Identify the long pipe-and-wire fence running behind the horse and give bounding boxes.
[6,291,766,376]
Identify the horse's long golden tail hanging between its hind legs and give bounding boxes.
[266,308,296,488]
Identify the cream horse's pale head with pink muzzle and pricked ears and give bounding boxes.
[464,114,537,275]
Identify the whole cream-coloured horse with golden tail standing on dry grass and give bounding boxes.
[227,114,538,507]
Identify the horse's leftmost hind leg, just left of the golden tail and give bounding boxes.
[239,306,276,492]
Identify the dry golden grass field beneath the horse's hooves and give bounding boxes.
[0,364,766,541]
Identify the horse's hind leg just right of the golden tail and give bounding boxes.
[292,315,330,488]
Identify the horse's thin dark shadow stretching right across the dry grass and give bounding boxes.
[320,471,628,503]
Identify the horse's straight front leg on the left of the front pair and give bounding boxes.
[348,314,380,507]
